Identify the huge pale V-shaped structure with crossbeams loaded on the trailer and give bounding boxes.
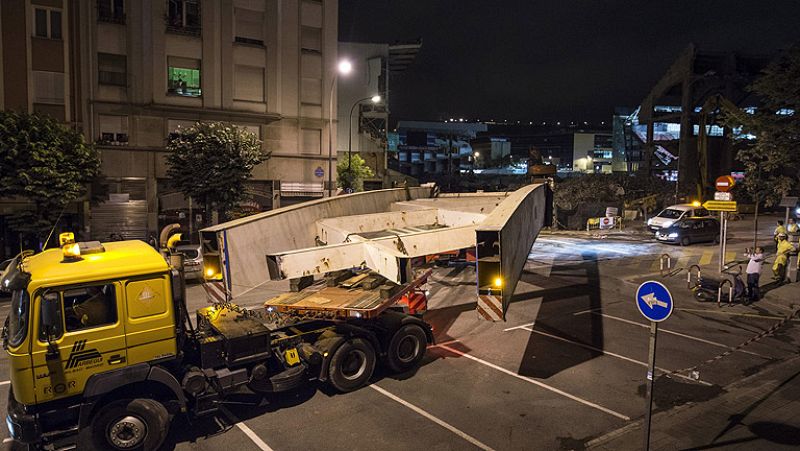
[201,184,552,321]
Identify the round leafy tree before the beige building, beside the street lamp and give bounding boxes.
[167,122,269,224]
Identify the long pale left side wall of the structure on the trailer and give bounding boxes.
[203,188,430,297]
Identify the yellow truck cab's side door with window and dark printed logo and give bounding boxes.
[31,282,127,402]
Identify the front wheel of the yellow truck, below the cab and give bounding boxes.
[91,398,169,451]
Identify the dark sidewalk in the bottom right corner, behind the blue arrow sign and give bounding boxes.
[586,356,800,451]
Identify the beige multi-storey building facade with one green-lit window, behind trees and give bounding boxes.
[0,0,338,249]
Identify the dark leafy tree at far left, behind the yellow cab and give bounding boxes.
[0,111,100,239]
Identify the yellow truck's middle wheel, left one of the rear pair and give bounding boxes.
[328,338,375,393]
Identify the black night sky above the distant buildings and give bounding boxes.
[339,0,800,122]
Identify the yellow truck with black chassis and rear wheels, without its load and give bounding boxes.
[0,234,432,450]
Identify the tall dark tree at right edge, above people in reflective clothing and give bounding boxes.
[723,46,800,247]
